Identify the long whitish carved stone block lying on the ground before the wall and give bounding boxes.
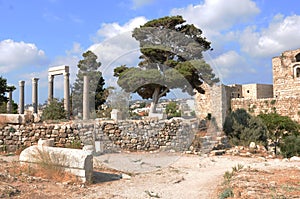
[19,146,93,183]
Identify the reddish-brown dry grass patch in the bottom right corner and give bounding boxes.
[218,168,300,199]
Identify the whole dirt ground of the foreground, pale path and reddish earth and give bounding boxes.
[0,153,300,199]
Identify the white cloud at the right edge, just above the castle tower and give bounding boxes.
[240,15,300,57]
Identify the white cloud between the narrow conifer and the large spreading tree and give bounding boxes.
[88,17,147,86]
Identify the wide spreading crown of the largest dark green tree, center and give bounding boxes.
[114,16,219,112]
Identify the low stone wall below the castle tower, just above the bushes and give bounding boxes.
[231,97,300,122]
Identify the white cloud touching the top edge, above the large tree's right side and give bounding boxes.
[171,0,260,34]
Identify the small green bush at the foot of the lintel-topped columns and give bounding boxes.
[42,98,67,121]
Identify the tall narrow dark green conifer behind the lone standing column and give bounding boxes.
[72,51,108,115]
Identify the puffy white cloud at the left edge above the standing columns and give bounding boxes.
[0,39,46,73]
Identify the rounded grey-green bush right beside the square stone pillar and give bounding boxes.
[223,109,267,146]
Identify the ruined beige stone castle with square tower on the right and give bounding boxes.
[195,49,300,129]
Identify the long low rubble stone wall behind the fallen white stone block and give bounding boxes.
[0,119,199,152]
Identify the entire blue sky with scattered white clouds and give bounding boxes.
[0,0,300,103]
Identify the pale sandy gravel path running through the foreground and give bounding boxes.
[84,153,300,199]
